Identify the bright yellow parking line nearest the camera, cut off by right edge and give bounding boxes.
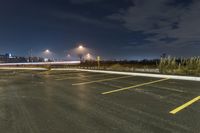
[169,96,200,115]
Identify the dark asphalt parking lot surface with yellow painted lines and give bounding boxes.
[0,70,200,133]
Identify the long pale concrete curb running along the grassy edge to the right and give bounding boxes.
[51,68,200,81]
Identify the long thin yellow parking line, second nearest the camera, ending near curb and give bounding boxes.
[101,78,169,95]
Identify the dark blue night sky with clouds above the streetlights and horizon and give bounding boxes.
[0,0,200,59]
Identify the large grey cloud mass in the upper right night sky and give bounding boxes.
[108,0,200,50]
